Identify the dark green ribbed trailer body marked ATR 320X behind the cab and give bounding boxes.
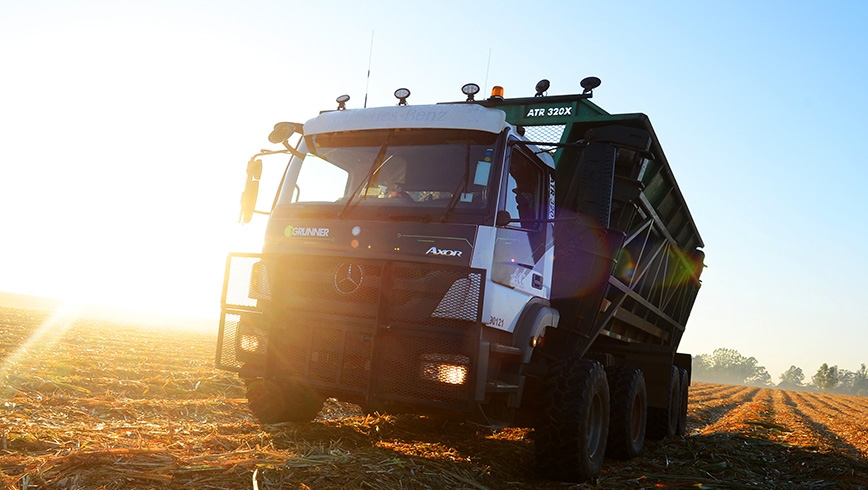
[483,96,704,355]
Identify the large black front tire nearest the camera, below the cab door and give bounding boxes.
[534,359,609,482]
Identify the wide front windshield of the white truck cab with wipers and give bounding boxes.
[278,128,498,214]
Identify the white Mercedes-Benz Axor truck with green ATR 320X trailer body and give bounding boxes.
[216,77,705,481]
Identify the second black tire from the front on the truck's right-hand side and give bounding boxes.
[606,366,648,459]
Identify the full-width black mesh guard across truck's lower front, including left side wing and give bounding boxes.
[217,254,485,410]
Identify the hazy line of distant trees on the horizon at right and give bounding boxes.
[692,348,868,396]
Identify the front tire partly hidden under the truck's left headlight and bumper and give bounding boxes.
[247,379,325,424]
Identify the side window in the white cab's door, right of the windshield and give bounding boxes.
[506,149,543,228]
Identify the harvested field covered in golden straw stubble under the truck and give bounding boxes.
[0,308,868,490]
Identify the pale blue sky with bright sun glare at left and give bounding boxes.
[0,0,868,381]
